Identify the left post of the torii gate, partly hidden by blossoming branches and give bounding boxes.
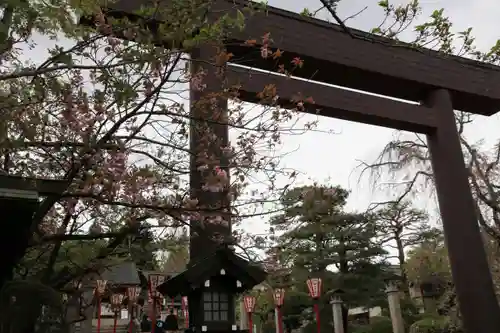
[189,45,231,261]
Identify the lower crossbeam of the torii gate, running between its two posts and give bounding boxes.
[226,66,437,134]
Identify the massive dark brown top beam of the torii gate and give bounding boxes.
[108,0,500,115]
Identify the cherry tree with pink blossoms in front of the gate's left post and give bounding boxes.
[0,0,320,331]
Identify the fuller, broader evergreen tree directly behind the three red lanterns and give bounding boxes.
[271,186,386,312]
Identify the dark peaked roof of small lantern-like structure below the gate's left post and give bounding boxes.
[158,246,267,297]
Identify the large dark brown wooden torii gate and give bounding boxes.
[95,0,500,333]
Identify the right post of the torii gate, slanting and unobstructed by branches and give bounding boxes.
[424,89,500,333]
